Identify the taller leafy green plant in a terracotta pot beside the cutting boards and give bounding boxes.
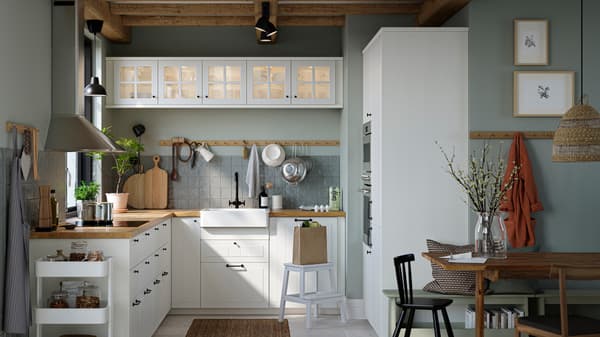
[93,127,144,212]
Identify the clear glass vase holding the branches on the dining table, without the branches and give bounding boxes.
[473,212,506,259]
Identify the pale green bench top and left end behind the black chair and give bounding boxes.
[383,289,539,336]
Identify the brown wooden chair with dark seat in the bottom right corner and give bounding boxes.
[515,266,600,337]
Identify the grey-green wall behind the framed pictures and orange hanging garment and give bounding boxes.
[468,0,600,251]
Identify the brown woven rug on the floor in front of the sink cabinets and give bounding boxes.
[185,319,290,337]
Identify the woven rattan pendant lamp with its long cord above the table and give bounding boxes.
[552,0,600,162]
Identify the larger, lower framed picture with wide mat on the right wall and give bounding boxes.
[513,71,575,117]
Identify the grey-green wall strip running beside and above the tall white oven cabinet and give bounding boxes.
[340,15,415,298]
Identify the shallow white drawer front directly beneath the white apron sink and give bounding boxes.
[201,239,269,262]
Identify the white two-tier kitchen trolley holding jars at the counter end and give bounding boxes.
[33,258,113,337]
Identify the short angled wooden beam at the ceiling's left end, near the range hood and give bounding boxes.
[83,0,131,43]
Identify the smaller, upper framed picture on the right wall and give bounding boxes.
[514,19,548,66]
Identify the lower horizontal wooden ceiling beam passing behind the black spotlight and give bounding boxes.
[123,16,346,27]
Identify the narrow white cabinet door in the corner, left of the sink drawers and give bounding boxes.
[171,218,201,308]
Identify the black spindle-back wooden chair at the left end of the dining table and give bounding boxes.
[392,254,454,337]
